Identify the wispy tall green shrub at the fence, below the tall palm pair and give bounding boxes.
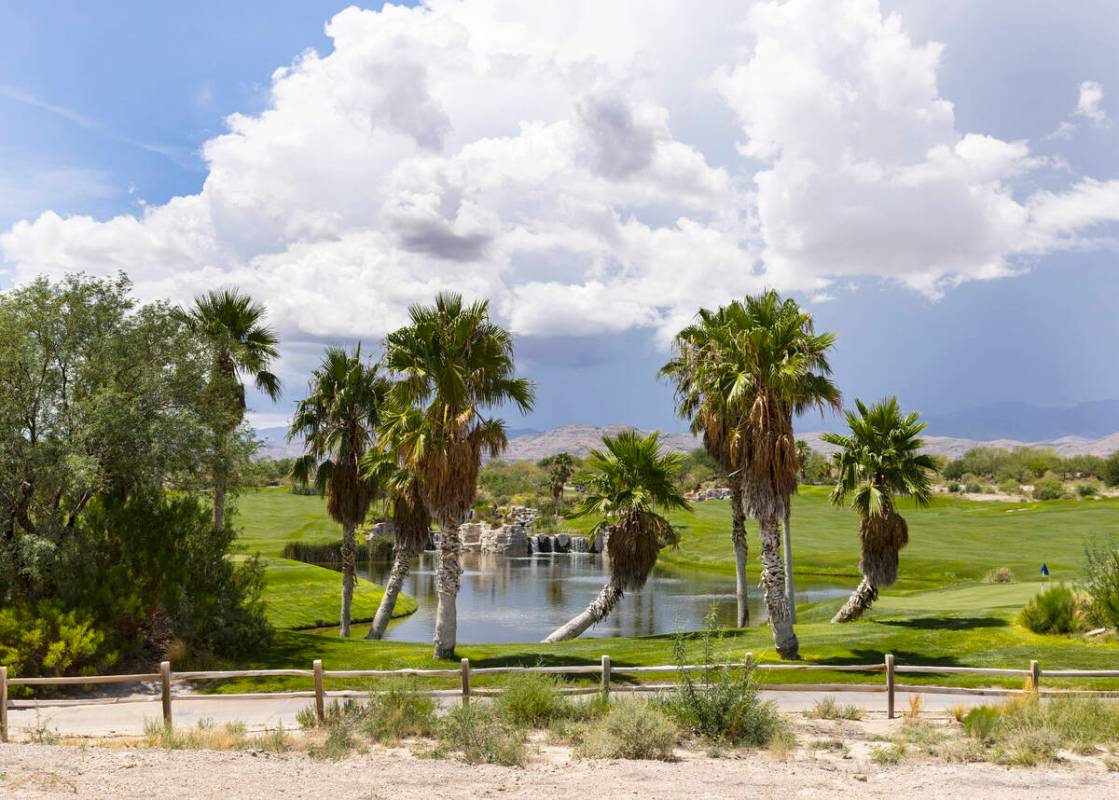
[662,605,784,747]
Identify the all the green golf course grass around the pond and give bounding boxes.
[217,487,1119,691]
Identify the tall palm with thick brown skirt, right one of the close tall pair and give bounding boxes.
[723,291,839,658]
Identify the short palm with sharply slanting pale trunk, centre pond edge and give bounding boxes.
[544,431,688,642]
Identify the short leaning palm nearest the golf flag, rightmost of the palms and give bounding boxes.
[824,397,937,622]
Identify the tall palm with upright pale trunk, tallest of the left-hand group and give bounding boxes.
[384,293,534,658]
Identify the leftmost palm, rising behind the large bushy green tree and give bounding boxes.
[182,289,280,528]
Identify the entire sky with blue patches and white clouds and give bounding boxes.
[0,0,1119,430]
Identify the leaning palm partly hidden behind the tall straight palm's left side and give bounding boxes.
[361,410,431,639]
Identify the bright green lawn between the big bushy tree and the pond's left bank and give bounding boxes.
[235,488,416,630]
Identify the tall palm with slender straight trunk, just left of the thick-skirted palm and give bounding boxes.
[660,308,750,628]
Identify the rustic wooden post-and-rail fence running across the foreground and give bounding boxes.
[0,652,1119,742]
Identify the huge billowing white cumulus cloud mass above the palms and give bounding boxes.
[0,0,1119,360]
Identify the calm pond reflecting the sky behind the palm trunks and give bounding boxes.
[320,552,855,643]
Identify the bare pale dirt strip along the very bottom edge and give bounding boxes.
[0,744,1119,800]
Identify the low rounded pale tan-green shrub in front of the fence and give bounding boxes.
[575,699,677,761]
